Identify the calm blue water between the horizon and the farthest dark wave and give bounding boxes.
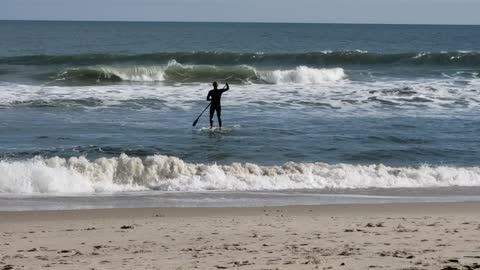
[0,21,480,56]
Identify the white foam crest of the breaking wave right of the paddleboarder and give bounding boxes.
[257,66,345,84]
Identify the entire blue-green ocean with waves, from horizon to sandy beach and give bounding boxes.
[0,21,480,210]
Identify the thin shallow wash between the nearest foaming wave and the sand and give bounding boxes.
[0,187,480,212]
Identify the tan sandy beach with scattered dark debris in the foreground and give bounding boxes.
[0,203,480,269]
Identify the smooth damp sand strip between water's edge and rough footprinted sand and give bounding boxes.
[0,201,480,218]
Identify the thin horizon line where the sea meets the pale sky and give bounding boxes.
[0,19,480,26]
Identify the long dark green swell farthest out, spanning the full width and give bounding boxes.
[0,50,480,67]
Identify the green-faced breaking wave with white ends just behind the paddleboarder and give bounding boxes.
[52,61,345,84]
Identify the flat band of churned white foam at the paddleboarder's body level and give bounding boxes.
[0,73,480,117]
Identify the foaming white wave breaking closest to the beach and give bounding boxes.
[0,154,480,194]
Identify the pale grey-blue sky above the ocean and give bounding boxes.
[0,0,480,24]
